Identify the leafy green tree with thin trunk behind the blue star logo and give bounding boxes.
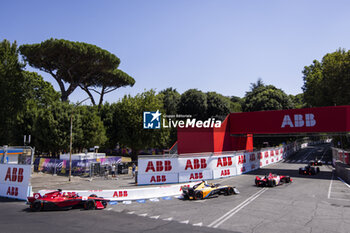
[113,90,169,161]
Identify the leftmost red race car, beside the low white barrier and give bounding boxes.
[27,189,109,211]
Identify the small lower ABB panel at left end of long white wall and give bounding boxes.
[137,173,179,185]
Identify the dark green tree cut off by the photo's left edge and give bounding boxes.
[0,40,24,145]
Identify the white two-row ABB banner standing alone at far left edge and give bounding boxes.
[0,164,31,200]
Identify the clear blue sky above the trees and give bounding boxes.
[0,0,350,102]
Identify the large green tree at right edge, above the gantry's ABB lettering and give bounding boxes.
[302,49,350,107]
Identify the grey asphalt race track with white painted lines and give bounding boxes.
[0,145,350,233]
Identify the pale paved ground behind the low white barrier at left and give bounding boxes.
[31,172,142,192]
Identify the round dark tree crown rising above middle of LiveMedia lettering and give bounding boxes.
[178,89,208,120]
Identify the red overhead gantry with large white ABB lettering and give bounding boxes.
[177,105,350,154]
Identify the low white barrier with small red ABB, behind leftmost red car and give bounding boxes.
[39,182,198,201]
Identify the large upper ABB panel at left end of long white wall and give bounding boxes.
[138,158,179,174]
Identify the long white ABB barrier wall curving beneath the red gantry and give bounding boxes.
[137,143,300,185]
